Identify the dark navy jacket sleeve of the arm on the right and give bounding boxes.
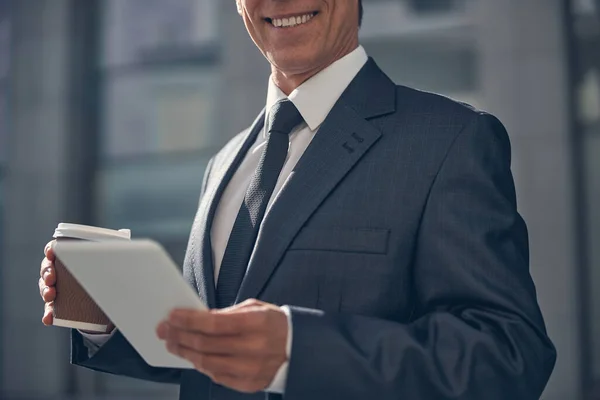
[284,114,556,400]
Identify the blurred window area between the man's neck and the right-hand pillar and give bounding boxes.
[360,0,479,106]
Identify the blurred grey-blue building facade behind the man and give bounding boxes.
[0,0,600,400]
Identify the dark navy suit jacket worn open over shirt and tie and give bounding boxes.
[72,60,555,400]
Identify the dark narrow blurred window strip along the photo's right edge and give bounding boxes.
[571,0,600,398]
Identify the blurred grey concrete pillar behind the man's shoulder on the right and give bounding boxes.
[474,0,581,400]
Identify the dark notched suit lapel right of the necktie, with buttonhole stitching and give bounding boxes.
[237,59,396,301]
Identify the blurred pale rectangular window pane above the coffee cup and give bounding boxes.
[102,66,218,157]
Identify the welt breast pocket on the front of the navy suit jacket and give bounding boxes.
[288,227,390,254]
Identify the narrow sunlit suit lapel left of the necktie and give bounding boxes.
[188,110,265,308]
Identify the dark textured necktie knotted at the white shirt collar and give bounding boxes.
[217,100,302,308]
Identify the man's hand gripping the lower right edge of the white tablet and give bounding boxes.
[157,300,288,393]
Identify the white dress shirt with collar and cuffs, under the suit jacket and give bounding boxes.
[83,46,368,394]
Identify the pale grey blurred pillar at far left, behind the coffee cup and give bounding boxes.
[0,0,70,398]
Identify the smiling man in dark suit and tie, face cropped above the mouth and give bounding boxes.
[40,0,555,400]
